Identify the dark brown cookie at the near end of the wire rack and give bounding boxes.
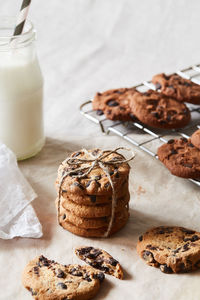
[158,138,200,178]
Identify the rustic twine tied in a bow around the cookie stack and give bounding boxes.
[58,147,135,237]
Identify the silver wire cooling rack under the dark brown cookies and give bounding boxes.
[80,64,200,186]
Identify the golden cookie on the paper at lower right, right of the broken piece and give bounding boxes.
[137,226,200,273]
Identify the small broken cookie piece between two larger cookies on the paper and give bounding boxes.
[75,247,123,279]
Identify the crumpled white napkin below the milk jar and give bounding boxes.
[0,143,42,239]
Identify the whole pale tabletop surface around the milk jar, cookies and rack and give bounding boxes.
[0,0,200,300]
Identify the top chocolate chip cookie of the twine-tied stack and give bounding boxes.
[56,149,130,196]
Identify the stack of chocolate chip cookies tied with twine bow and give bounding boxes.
[56,149,130,237]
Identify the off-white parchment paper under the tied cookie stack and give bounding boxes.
[0,137,200,300]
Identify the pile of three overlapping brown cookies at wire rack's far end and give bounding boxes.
[92,74,200,129]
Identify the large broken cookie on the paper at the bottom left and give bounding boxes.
[22,255,104,300]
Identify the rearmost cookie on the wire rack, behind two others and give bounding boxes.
[152,73,200,104]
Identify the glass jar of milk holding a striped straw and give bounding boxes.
[0,17,44,160]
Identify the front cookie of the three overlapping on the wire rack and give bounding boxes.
[130,90,191,129]
